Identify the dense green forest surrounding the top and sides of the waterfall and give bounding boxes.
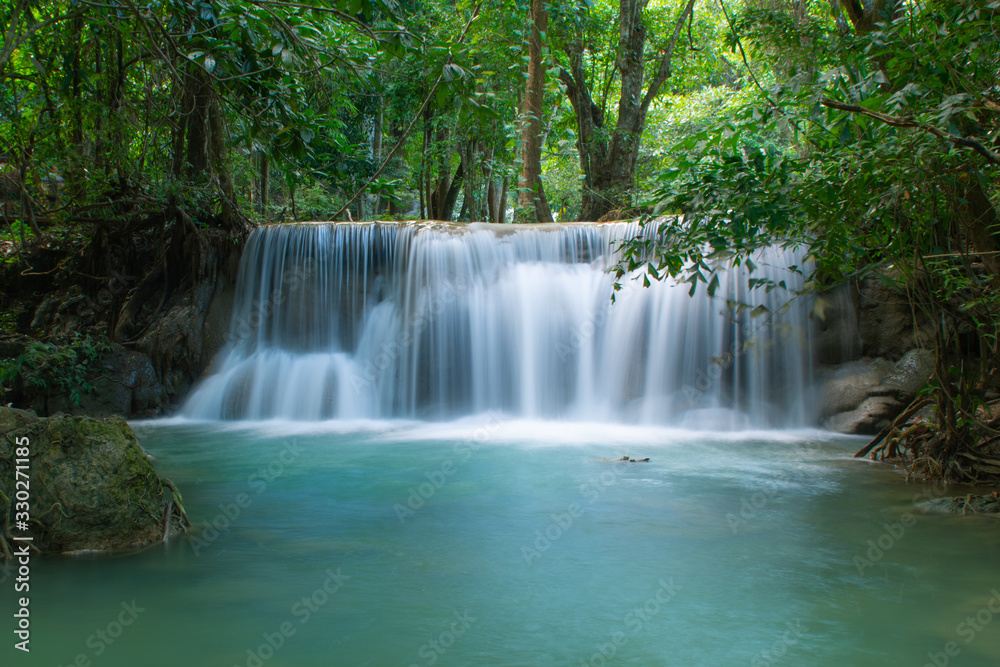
[0,0,1000,478]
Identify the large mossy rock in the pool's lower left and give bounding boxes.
[0,408,185,552]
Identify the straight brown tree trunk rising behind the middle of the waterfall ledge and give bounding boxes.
[517,0,552,222]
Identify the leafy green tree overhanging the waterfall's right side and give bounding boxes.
[618,0,1000,479]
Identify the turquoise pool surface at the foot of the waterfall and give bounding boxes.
[2,422,1000,667]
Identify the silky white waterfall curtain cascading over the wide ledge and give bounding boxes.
[183,223,811,429]
